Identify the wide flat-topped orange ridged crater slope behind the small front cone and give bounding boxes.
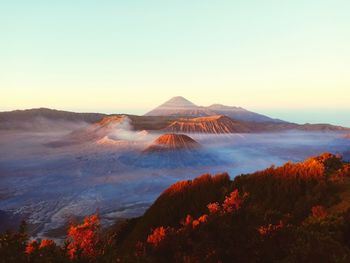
[165,115,251,134]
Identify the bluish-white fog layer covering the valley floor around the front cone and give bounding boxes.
[0,118,350,240]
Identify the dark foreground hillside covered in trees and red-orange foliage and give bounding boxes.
[0,153,350,262]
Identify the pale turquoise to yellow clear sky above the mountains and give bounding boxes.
[0,0,350,126]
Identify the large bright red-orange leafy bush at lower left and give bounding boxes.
[68,215,100,258]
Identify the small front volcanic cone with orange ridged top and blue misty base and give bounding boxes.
[119,134,216,168]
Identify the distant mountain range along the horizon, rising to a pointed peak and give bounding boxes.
[0,96,350,133]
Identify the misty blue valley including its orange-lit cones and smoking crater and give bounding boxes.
[0,98,350,241]
